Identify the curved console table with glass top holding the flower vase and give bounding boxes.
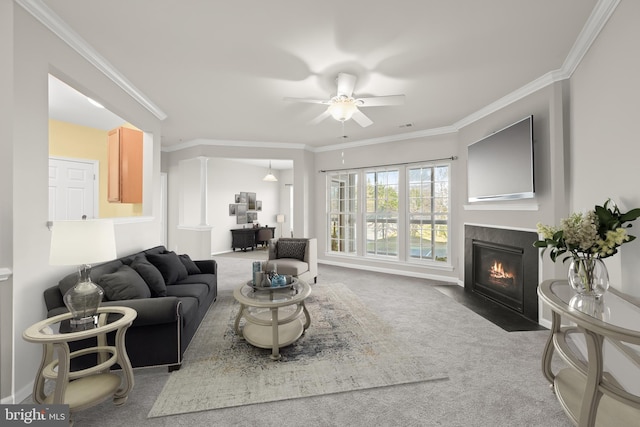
[538,280,640,427]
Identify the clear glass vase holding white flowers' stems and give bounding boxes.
[569,256,609,298]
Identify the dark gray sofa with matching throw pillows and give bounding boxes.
[44,246,218,370]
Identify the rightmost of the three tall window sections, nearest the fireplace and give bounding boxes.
[407,165,449,262]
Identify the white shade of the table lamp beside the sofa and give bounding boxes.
[49,220,116,265]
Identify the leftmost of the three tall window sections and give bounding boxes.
[327,172,358,254]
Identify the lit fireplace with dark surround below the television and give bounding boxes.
[464,225,539,322]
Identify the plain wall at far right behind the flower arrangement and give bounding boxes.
[570,1,640,296]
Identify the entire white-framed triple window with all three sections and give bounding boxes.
[327,163,451,266]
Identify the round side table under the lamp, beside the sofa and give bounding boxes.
[22,306,138,422]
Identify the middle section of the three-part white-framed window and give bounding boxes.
[365,170,399,257]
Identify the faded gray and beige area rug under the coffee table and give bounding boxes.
[148,283,448,417]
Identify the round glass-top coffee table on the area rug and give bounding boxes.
[233,280,311,360]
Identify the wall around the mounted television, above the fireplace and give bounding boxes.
[455,81,568,281]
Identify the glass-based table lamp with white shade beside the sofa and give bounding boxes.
[49,220,116,329]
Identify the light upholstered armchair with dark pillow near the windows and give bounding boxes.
[267,237,318,283]
